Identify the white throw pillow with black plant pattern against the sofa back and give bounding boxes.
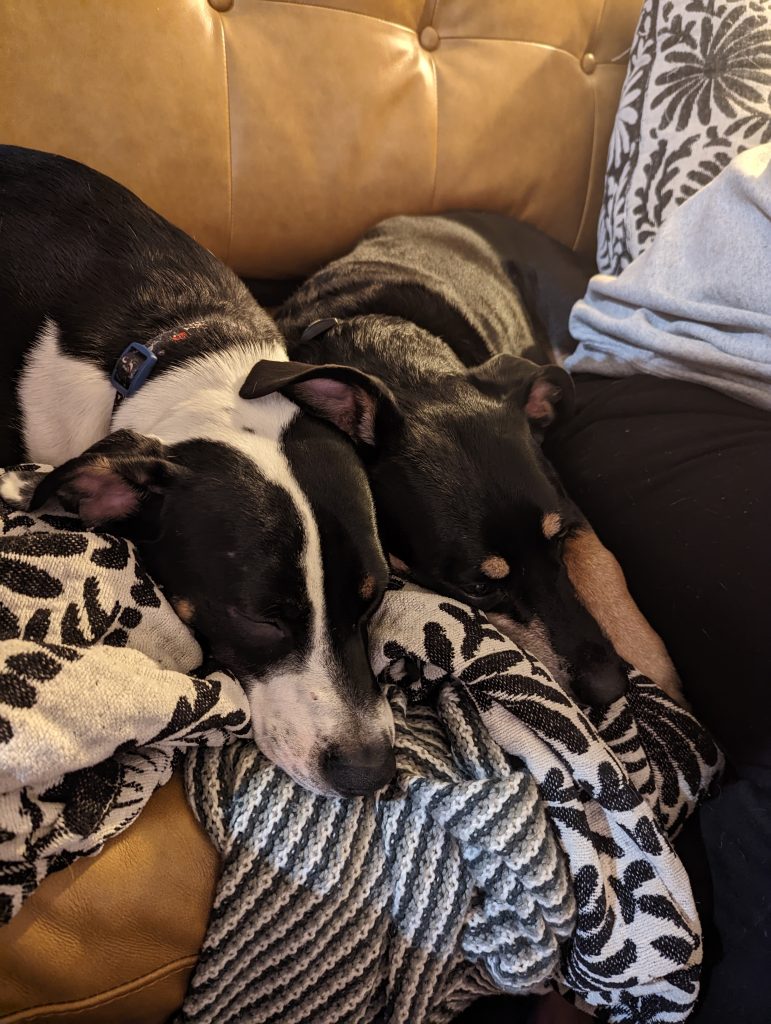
[597,0,771,274]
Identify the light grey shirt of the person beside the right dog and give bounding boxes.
[565,143,771,409]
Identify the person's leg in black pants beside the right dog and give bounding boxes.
[546,376,771,1024]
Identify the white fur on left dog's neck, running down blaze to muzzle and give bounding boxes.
[115,348,394,794]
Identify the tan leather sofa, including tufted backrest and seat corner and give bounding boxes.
[0,0,641,1024]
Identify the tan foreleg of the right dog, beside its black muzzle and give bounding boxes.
[563,526,687,707]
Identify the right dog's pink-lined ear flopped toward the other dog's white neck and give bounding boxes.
[239,359,396,444]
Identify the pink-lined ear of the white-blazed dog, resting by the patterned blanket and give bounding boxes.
[30,430,183,526]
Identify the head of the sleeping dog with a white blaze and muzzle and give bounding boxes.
[27,403,394,796]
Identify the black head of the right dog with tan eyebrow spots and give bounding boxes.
[262,338,627,703]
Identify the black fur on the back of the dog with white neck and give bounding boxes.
[0,145,271,465]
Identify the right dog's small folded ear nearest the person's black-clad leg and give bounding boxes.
[468,352,573,427]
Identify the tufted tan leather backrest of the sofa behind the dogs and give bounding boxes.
[0,0,640,276]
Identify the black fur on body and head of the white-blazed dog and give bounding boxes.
[0,146,393,792]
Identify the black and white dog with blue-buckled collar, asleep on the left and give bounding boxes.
[0,146,394,795]
